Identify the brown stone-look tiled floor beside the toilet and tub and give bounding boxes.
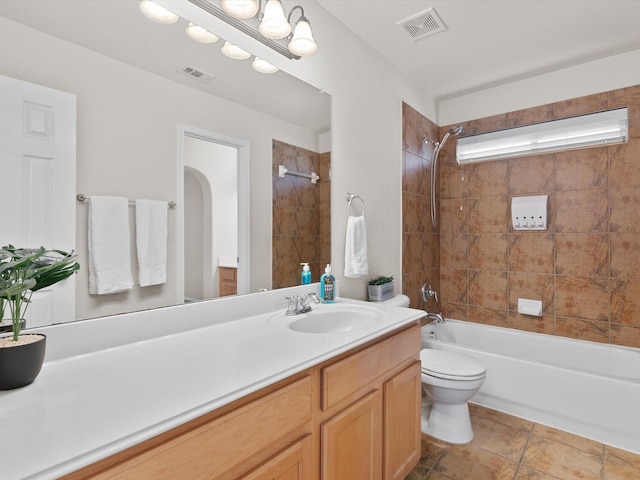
[405,404,640,480]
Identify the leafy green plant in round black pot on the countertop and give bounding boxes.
[0,245,80,390]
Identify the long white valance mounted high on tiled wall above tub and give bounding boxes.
[456,107,629,164]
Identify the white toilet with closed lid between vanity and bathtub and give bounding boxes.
[420,348,486,444]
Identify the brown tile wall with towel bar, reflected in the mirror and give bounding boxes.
[272,140,331,288]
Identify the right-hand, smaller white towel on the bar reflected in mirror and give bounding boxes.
[136,200,167,287]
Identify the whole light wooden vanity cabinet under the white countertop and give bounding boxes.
[64,323,421,480]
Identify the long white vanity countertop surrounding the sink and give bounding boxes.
[0,292,424,480]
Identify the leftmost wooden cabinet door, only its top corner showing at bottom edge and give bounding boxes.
[242,435,313,480]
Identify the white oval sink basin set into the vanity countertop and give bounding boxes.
[269,305,382,333]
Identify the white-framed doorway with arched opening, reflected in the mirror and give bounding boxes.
[181,127,249,302]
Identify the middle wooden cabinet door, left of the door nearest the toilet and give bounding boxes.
[321,390,382,480]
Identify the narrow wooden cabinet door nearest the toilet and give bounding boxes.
[384,361,422,480]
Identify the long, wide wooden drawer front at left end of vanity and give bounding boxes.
[84,376,312,480]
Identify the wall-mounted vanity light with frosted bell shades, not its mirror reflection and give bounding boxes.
[188,0,318,60]
